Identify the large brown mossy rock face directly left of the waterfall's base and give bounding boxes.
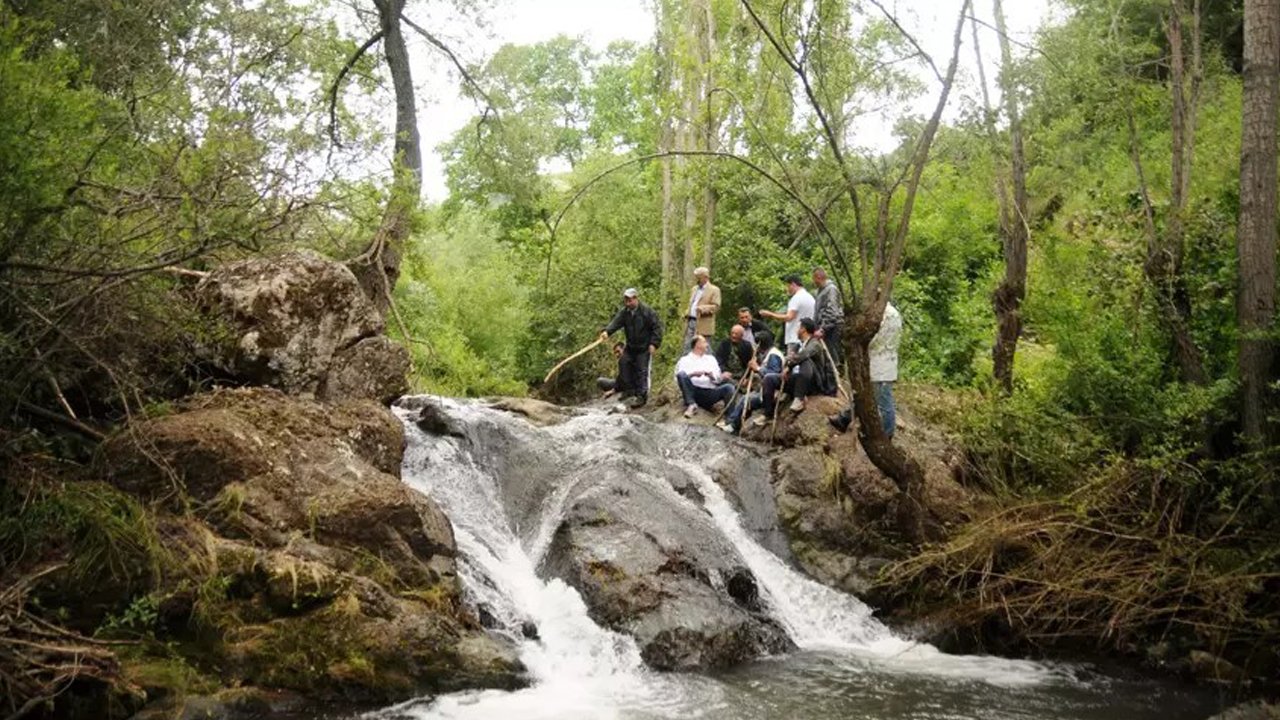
[96,388,522,702]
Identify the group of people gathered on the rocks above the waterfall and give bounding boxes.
[600,268,902,436]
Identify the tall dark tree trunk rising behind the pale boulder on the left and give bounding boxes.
[352,0,422,316]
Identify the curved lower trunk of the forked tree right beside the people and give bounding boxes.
[842,311,928,544]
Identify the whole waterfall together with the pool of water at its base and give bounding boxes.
[375,398,1218,720]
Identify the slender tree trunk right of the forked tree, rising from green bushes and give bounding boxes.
[992,0,1029,393]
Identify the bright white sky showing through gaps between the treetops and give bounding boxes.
[401,0,1061,201]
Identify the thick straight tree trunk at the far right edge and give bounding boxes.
[1236,0,1280,443]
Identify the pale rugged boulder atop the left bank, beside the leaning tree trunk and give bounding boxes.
[195,251,408,401]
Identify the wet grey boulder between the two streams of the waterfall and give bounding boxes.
[543,477,795,670]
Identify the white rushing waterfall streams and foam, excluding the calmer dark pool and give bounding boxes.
[379,398,1060,719]
